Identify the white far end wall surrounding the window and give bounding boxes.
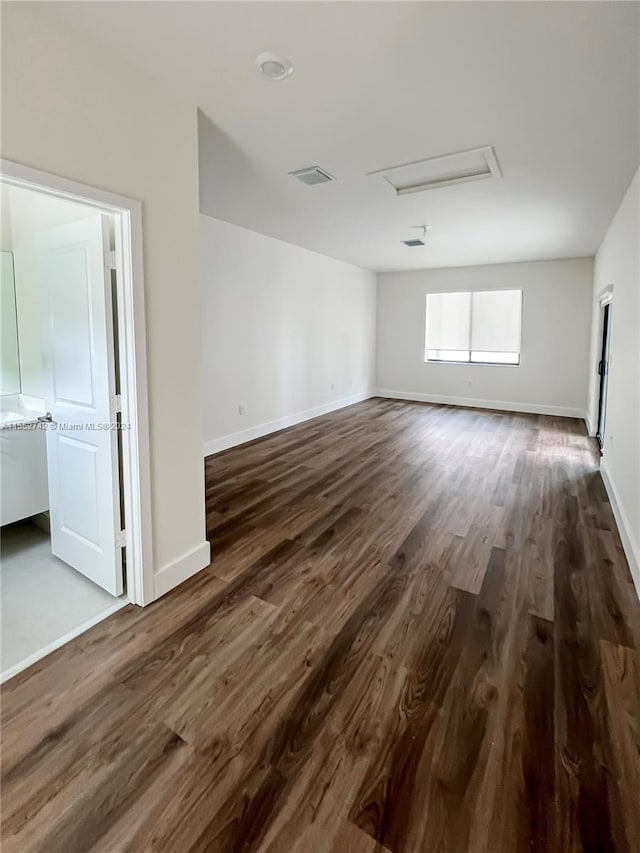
[377,258,593,417]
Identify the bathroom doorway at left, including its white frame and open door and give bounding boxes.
[0,161,154,681]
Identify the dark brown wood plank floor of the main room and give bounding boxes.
[2,399,640,853]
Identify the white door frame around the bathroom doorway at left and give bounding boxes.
[0,159,154,606]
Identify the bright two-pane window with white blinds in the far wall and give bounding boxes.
[425,290,522,364]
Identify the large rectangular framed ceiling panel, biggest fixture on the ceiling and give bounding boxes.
[367,145,500,195]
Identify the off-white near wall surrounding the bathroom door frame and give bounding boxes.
[2,3,206,588]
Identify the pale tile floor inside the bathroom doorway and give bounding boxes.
[0,522,119,677]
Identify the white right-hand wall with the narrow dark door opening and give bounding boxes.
[589,170,640,592]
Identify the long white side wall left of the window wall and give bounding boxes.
[200,215,376,453]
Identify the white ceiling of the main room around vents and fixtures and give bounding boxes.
[47,2,640,270]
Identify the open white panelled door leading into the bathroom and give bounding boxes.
[38,214,123,595]
